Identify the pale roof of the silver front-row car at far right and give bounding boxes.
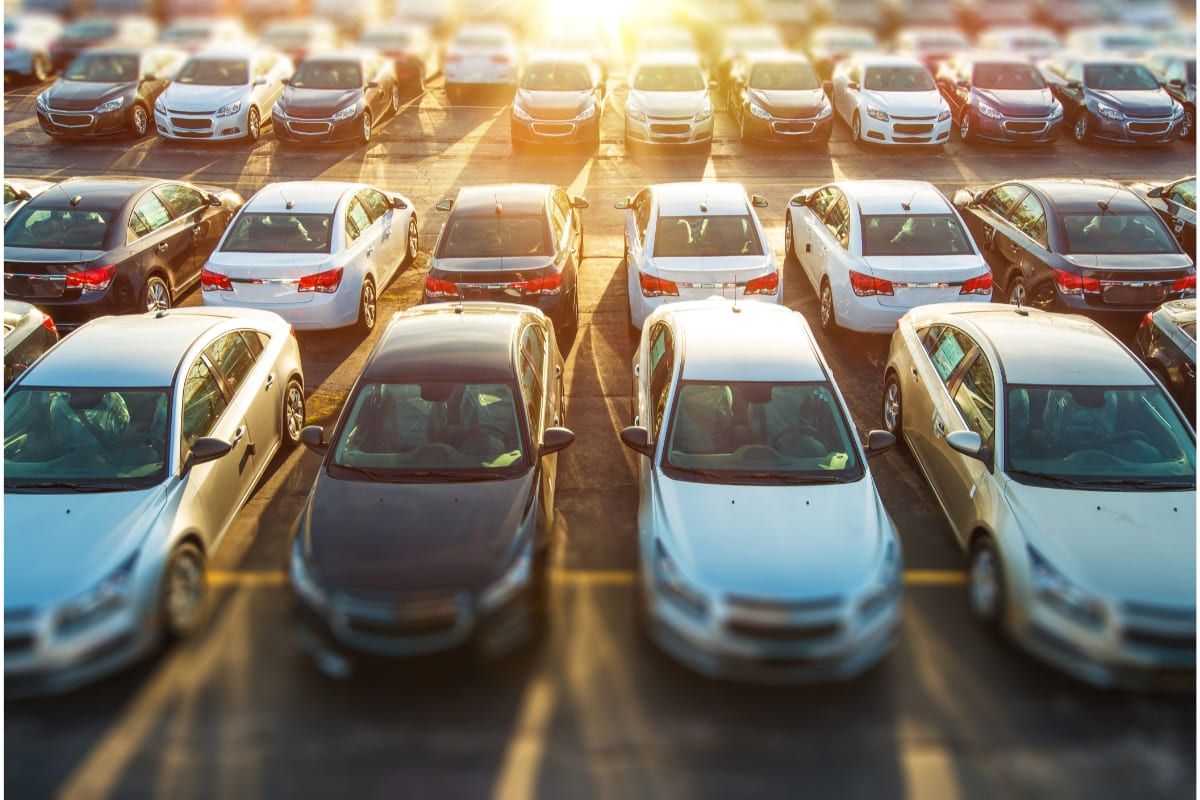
[926,303,1152,386]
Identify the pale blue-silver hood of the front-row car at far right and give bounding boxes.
[1006,481,1196,607]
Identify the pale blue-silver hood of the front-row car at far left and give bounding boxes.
[4,483,167,608]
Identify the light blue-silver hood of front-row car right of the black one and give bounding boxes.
[654,474,892,597]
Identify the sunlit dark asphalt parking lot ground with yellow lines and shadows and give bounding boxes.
[4,71,1195,799]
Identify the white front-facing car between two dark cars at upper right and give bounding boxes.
[833,54,954,146]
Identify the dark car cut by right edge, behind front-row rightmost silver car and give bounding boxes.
[1134,297,1196,425]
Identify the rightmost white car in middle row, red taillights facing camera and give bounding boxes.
[784,180,992,333]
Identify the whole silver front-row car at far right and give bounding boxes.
[883,303,1196,688]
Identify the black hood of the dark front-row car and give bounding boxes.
[300,470,536,594]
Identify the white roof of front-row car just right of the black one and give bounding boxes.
[667,300,828,381]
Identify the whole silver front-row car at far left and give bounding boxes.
[4,308,305,694]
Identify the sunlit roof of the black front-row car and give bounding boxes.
[362,302,520,383]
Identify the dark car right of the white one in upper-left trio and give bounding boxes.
[271,52,400,144]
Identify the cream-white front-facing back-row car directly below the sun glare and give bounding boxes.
[625,53,714,148]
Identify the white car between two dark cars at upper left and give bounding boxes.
[154,48,293,142]
